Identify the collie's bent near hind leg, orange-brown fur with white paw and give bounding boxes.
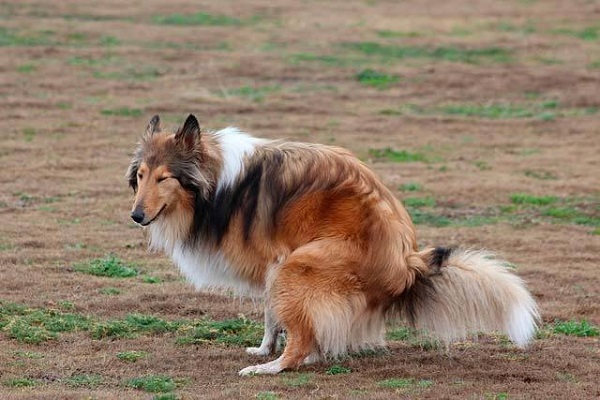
[240,240,364,375]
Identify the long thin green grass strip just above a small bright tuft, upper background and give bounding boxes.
[344,42,512,64]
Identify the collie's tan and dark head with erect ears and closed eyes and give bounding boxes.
[126,115,210,226]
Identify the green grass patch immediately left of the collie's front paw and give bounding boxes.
[177,318,263,346]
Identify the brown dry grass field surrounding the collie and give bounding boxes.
[0,0,600,399]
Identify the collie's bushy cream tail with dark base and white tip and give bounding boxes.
[395,248,539,347]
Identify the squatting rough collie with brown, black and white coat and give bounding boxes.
[127,115,538,375]
